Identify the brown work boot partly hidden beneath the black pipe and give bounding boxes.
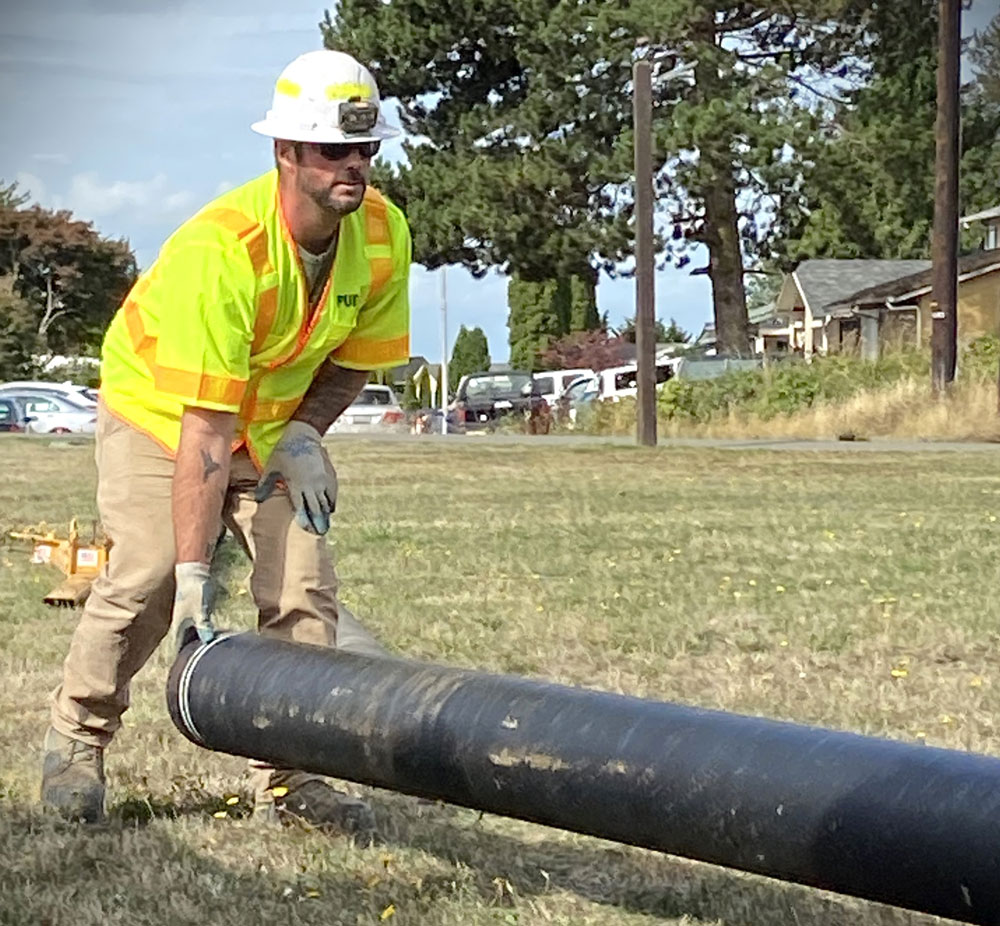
[254,769,377,846]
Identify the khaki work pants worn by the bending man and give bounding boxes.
[52,403,384,779]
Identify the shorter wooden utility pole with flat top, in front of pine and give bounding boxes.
[632,58,656,447]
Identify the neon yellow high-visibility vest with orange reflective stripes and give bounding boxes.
[101,170,411,466]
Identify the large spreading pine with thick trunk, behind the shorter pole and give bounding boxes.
[323,0,864,361]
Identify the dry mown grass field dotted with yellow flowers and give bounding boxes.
[0,438,1000,926]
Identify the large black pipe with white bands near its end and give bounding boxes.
[168,634,1000,924]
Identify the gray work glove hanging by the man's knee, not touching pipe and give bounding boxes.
[254,421,337,534]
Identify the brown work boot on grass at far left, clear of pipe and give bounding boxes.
[42,727,104,823]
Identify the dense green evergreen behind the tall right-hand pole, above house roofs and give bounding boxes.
[773,0,1000,269]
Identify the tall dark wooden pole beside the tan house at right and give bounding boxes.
[931,0,962,395]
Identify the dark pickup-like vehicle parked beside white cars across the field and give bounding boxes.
[452,370,549,433]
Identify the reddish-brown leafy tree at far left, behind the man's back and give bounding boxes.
[0,187,136,353]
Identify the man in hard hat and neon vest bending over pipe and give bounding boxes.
[42,51,410,835]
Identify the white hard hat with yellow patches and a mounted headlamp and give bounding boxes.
[250,50,399,142]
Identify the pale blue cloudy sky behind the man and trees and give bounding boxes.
[0,0,1000,361]
